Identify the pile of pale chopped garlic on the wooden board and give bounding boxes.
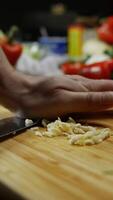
[31,118,113,146]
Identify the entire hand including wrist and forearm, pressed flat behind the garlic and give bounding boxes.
[0,48,113,117]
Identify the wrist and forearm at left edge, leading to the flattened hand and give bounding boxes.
[0,49,29,110]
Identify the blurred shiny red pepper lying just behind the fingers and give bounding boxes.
[61,59,113,79]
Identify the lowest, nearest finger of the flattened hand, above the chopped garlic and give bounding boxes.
[61,92,113,112]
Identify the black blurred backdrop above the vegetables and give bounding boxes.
[0,0,113,40]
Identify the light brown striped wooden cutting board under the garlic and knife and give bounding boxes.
[0,107,113,200]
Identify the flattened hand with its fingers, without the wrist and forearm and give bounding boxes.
[20,76,113,117]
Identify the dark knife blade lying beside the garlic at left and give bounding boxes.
[0,116,41,139]
